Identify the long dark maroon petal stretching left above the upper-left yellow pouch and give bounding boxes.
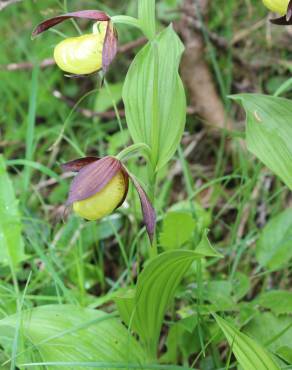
[32,10,110,37]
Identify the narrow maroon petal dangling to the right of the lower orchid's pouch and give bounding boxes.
[128,172,156,243]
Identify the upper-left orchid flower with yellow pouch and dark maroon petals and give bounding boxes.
[32,10,118,75]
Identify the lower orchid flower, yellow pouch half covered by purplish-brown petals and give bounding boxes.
[62,156,156,241]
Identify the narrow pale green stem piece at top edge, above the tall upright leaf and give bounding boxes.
[138,0,155,40]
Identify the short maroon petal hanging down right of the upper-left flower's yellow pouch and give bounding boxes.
[102,22,118,72]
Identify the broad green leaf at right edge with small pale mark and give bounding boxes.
[233,94,292,189]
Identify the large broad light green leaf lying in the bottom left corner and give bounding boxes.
[0,305,145,370]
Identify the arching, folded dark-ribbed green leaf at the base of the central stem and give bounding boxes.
[117,250,219,359]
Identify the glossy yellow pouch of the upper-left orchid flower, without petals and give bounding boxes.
[54,22,107,75]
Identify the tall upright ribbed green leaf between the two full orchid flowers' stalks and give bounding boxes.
[123,26,186,168]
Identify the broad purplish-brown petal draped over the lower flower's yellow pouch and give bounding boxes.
[67,157,122,205]
